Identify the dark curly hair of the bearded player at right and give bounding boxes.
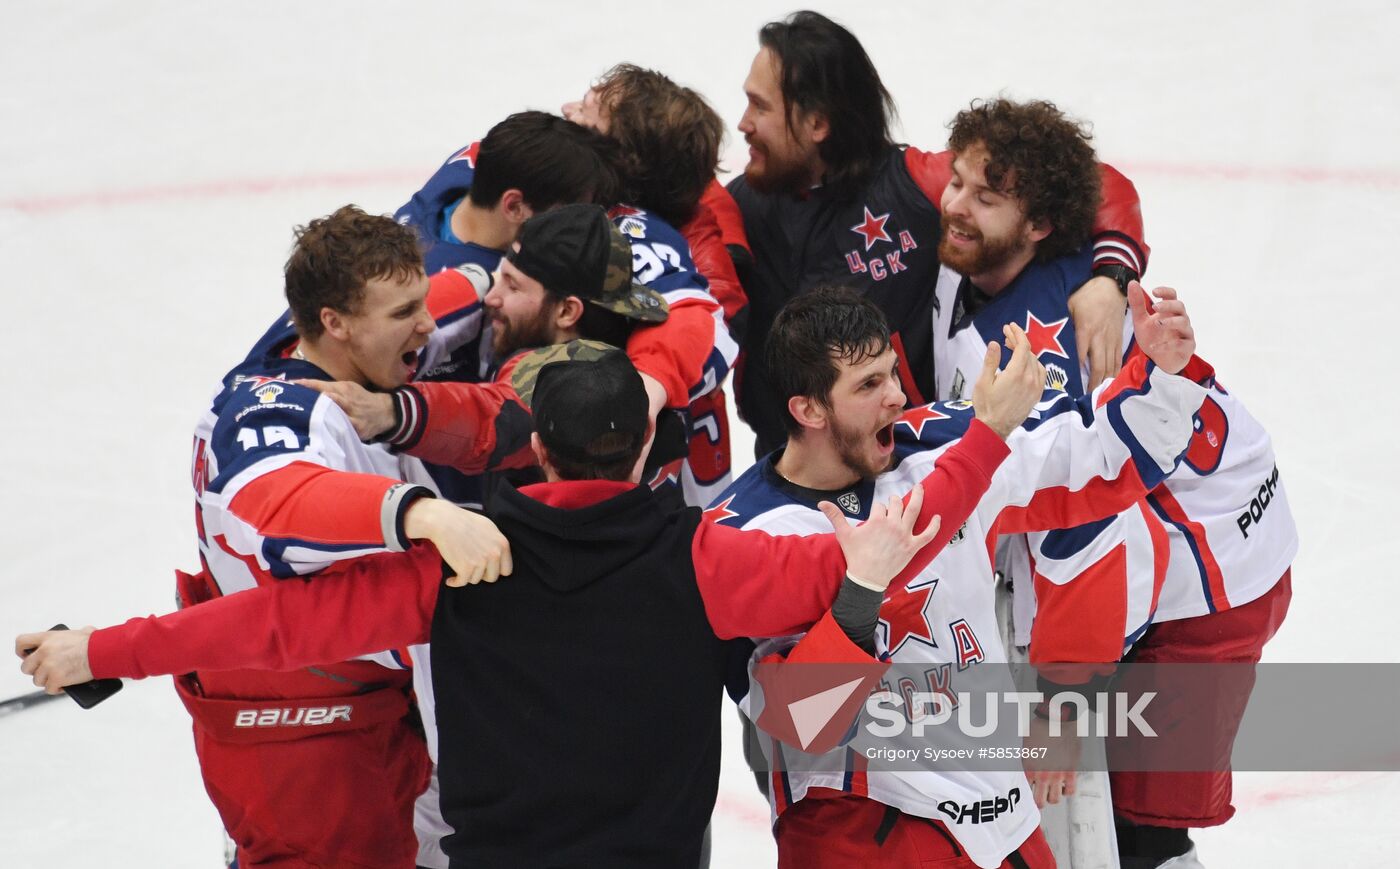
[948,98,1100,262]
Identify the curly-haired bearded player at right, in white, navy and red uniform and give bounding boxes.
[937,99,1298,869]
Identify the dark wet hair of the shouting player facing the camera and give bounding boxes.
[764,287,890,435]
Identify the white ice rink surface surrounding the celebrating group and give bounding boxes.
[0,0,1400,869]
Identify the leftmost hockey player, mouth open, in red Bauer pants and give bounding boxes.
[176,206,511,868]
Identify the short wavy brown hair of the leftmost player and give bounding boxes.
[284,206,423,340]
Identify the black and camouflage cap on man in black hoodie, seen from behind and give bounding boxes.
[511,340,651,465]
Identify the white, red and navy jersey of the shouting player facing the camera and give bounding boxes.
[708,358,1205,866]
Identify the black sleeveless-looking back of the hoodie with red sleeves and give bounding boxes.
[433,486,725,869]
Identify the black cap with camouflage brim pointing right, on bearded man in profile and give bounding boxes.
[505,204,669,323]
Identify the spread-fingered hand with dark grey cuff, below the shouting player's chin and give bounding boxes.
[816,486,942,589]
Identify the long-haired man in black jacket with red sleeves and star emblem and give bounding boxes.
[729,11,1147,455]
